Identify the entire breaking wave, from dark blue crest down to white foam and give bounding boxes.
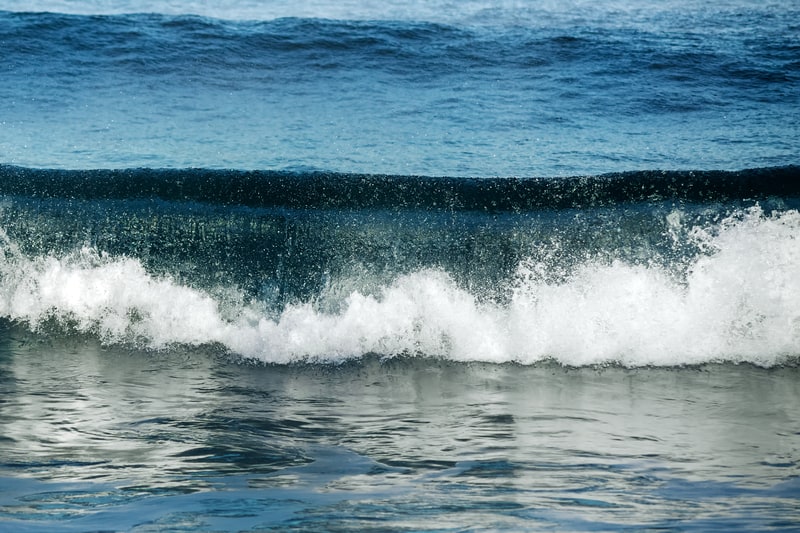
[0,166,800,366]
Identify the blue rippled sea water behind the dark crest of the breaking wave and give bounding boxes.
[0,2,800,177]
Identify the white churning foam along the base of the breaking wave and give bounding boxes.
[0,207,800,366]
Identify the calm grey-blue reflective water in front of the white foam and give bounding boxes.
[0,325,800,531]
